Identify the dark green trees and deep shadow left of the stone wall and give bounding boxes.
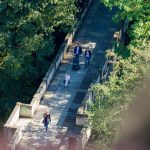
[0,0,91,125]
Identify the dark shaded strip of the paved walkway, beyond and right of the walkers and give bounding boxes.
[63,1,117,128]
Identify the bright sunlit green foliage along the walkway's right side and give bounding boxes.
[90,0,150,148]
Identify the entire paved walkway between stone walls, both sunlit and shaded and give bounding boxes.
[16,1,116,150]
